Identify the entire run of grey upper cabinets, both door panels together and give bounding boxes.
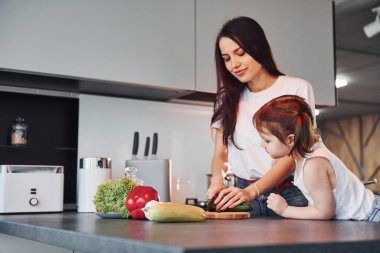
[0,0,336,105]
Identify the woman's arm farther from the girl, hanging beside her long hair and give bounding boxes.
[207,129,228,199]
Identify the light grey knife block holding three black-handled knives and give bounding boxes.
[125,132,171,202]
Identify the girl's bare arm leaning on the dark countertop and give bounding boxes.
[268,157,335,219]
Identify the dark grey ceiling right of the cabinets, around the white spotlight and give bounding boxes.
[318,0,380,121]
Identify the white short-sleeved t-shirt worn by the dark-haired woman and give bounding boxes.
[212,76,315,180]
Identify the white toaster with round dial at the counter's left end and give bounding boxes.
[0,165,64,213]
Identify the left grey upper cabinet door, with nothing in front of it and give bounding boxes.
[0,0,195,90]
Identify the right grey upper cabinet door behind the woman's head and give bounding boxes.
[196,0,336,105]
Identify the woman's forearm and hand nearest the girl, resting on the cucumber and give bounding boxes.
[215,157,295,210]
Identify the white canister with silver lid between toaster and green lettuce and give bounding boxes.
[77,157,112,212]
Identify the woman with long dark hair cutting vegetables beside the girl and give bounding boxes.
[207,17,314,216]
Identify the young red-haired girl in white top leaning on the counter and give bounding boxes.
[253,95,380,222]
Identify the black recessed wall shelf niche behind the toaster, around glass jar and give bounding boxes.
[0,91,79,207]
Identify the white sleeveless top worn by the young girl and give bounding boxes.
[294,141,375,220]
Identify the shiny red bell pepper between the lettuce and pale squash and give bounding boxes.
[125,185,159,220]
